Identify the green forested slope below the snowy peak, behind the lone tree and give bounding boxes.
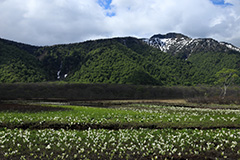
[188,52,240,84]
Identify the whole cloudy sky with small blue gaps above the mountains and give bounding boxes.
[0,0,240,47]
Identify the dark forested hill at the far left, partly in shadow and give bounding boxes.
[0,39,47,82]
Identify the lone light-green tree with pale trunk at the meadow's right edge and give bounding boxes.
[216,68,239,99]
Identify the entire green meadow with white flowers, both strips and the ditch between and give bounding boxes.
[0,100,240,159]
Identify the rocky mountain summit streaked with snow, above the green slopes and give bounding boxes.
[143,33,240,59]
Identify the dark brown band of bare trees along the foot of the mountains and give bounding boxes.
[0,83,240,103]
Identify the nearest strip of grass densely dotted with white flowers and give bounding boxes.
[0,128,240,159]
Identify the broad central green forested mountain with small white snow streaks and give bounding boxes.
[37,37,190,85]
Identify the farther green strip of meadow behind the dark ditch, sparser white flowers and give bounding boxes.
[0,105,240,129]
